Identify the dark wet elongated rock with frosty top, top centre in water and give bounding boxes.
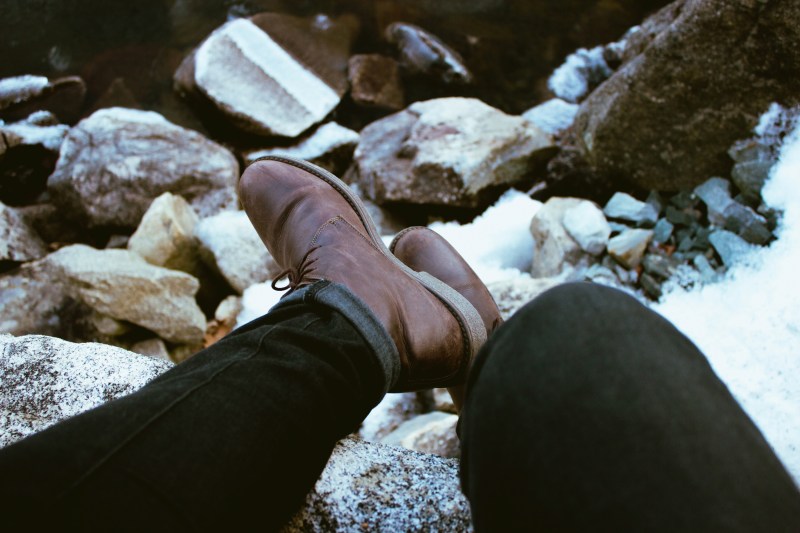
[385,22,472,84]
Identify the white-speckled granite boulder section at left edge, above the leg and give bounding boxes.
[0,335,172,447]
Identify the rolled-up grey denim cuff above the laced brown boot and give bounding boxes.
[271,280,400,393]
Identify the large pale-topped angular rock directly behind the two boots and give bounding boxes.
[355,98,553,207]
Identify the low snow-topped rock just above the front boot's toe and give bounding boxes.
[245,122,359,175]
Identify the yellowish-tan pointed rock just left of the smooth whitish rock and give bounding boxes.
[127,192,200,275]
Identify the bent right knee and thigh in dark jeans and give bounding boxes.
[461,284,800,531]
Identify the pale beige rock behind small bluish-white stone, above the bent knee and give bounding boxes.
[531,198,592,278]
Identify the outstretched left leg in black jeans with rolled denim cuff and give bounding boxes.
[0,282,396,531]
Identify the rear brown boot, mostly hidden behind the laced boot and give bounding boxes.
[389,227,503,412]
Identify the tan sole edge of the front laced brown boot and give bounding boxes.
[251,155,486,386]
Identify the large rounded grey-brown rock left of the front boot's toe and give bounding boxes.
[48,108,239,229]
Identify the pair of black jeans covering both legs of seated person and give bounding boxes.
[0,284,800,531]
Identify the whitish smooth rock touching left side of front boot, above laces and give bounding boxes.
[195,211,280,294]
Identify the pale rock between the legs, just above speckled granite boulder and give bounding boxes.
[381,411,461,458]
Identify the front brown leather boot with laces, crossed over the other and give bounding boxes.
[239,156,486,392]
